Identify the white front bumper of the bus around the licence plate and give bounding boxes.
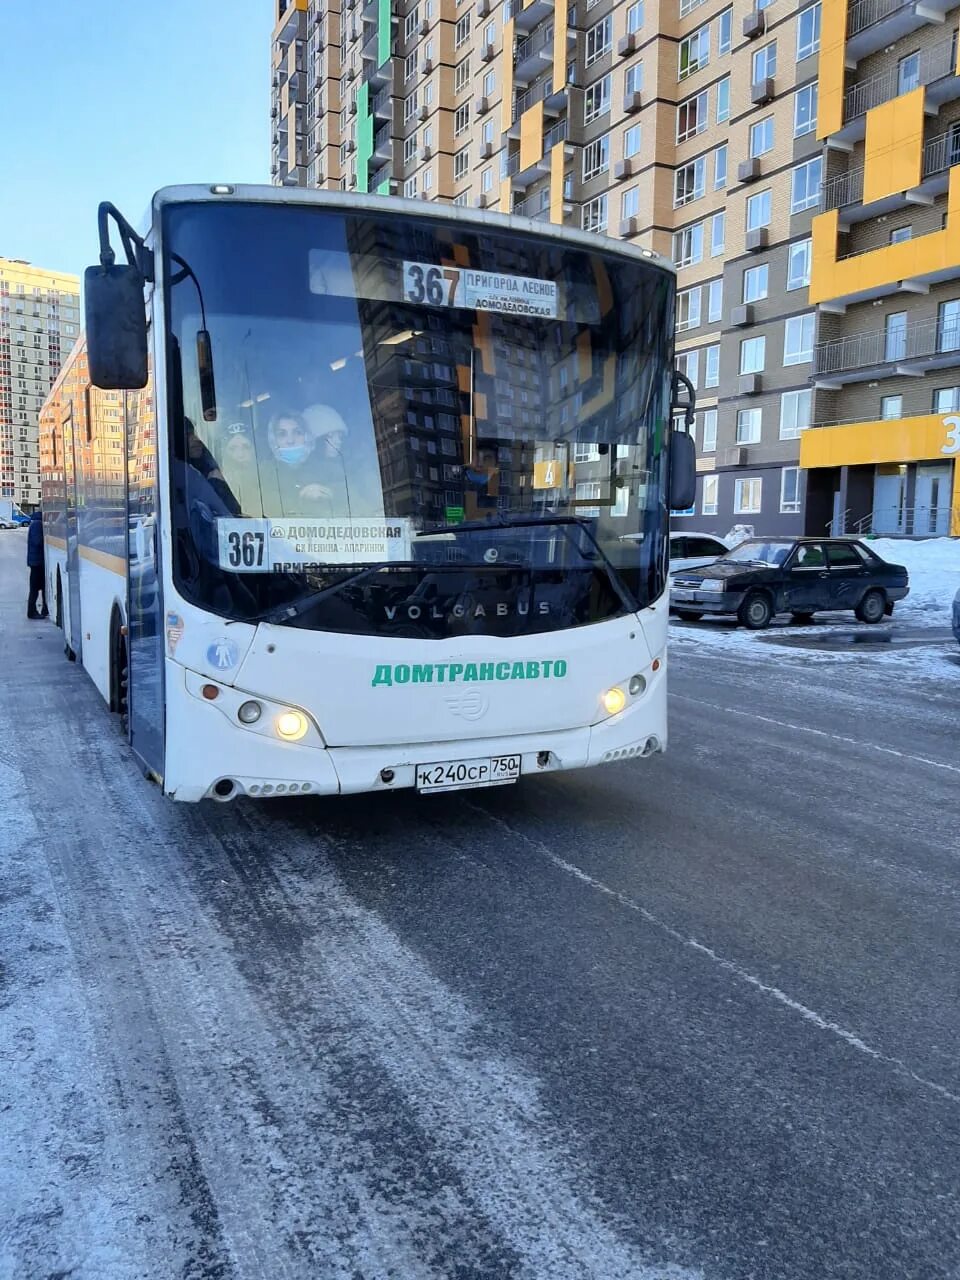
[164,668,667,801]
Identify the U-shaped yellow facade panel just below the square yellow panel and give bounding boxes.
[810,169,960,302]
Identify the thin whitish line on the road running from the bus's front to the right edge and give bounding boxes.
[468,804,960,1103]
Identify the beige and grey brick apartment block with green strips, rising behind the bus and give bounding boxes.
[271,0,823,532]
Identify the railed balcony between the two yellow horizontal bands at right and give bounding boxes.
[814,319,960,389]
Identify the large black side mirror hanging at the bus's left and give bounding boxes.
[83,265,147,392]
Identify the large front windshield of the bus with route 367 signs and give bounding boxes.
[164,202,673,639]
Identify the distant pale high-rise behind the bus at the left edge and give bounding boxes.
[0,257,79,511]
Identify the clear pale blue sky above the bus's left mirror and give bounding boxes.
[0,0,274,274]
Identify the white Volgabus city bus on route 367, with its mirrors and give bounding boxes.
[41,186,694,801]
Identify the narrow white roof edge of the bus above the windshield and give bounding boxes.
[152,183,676,275]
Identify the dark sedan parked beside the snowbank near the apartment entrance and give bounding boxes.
[669,538,910,631]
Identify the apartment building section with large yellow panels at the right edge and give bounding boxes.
[801,0,960,535]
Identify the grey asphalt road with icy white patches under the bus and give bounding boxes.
[0,522,960,1280]
